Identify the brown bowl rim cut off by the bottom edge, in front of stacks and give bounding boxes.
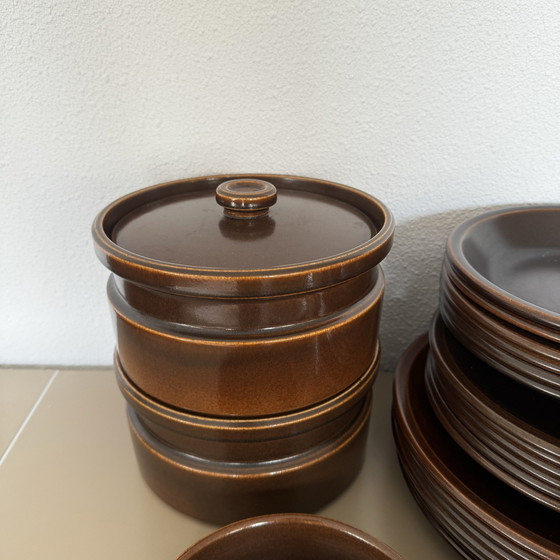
[178,514,402,560]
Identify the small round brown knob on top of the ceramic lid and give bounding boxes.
[216,179,276,219]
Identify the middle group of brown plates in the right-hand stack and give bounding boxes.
[426,317,560,511]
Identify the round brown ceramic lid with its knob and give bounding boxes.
[93,175,394,296]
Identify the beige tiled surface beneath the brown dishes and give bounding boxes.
[0,369,460,560]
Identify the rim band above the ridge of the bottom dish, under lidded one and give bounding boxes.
[115,346,379,463]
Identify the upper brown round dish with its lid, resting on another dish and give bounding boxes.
[93,175,394,418]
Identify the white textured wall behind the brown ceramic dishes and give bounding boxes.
[0,0,560,367]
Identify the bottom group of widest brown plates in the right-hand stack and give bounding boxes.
[393,335,560,560]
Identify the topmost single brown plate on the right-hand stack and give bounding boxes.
[446,206,560,335]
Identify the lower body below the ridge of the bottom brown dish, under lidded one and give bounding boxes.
[128,390,372,525]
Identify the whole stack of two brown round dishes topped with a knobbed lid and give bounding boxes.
[93,175,394,524]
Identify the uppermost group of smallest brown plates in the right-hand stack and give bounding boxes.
[441,206,560,398]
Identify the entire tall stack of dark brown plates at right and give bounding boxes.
[393,206,560,559]
